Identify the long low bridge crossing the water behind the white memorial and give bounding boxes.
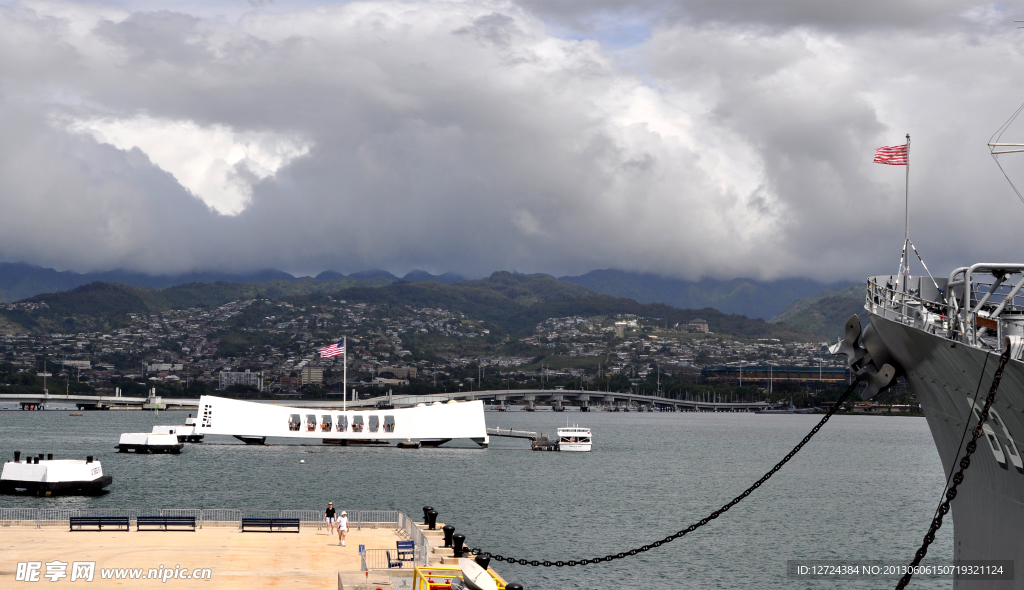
[0,389,769,412]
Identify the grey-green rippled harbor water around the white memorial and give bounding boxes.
[0,411,954,590]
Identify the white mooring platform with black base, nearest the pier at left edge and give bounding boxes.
[0,451,114,496]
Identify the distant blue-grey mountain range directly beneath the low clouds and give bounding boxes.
[0,262,863,339]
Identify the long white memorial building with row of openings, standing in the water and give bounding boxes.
[197,395,490,449]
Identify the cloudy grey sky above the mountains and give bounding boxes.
[0,0,1024,281]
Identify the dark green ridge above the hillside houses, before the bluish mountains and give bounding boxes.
[0,272,817,341]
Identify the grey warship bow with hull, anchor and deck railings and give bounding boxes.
[831,263,1024,589]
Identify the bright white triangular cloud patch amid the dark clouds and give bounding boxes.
[68,117,310,215]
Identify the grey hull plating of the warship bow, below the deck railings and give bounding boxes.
[868,312,1024,590]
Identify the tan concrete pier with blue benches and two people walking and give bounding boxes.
[0,522,419,590]
